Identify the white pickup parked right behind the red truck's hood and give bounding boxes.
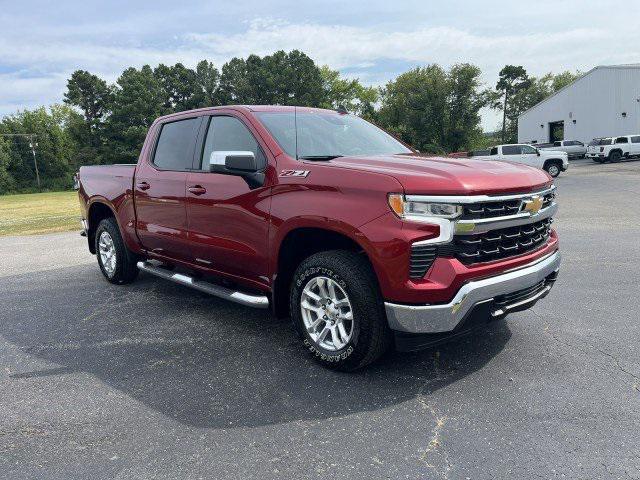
[474,143,569,177]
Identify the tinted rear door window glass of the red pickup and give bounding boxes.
[153,118,200,171]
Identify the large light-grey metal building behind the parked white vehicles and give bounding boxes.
[518,64,640,143]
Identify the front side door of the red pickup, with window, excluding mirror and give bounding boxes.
[187,114,271,285]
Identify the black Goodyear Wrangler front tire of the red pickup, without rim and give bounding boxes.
[289,250,392,371]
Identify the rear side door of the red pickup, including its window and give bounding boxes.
[134,117,201,260]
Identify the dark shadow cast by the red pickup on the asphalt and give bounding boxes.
[0,266,511,428]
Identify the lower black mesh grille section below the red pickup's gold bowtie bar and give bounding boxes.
[453,218,552,263]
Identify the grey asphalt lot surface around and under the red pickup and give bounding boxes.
[0,162,640,479]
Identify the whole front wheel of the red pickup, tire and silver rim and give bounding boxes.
[289,250,392,371]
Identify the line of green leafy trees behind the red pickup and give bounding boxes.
[0,50,573,194]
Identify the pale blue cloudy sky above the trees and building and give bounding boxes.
[0,0,640,130]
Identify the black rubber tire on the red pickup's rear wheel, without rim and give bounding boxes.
[95,217,138,285]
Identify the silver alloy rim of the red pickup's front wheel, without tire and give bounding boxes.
[300,277,353,351]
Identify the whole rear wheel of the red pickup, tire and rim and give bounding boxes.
[95,217,138,284]
